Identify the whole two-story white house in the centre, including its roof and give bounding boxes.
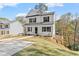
[24,3,55,36]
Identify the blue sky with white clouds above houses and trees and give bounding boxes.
[0,3,79,20]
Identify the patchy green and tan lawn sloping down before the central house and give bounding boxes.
[13,36,79,56]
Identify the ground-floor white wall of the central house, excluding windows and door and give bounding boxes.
[26,25,54,36]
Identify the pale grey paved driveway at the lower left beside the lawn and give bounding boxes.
[0,40,32,56]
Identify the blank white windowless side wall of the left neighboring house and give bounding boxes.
[9,20,24,36]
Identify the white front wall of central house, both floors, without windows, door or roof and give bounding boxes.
[25,15,55,36]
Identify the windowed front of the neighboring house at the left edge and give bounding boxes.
[0,18,10,35]
